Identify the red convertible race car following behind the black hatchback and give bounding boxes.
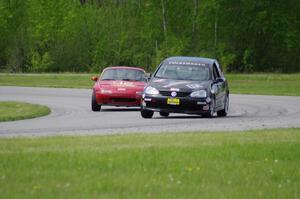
[91,66,147,111]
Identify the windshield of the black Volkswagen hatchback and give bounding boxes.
[155,64,211,81]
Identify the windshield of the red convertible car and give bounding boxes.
[101,68,146,81]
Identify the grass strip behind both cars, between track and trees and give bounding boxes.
[0,73,300,96]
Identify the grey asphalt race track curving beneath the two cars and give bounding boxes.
[0,87,300,136]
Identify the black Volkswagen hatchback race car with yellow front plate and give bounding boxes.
[141,57,229,118]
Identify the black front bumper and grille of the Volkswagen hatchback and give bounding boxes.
[141,95,211,114]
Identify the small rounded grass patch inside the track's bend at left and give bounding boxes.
[0,101,50,122]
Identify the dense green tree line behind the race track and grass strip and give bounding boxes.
[0,0,300,72]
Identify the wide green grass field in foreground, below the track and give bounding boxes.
[0,129,300,199]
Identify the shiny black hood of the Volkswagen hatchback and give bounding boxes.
[149,78,212,92]
